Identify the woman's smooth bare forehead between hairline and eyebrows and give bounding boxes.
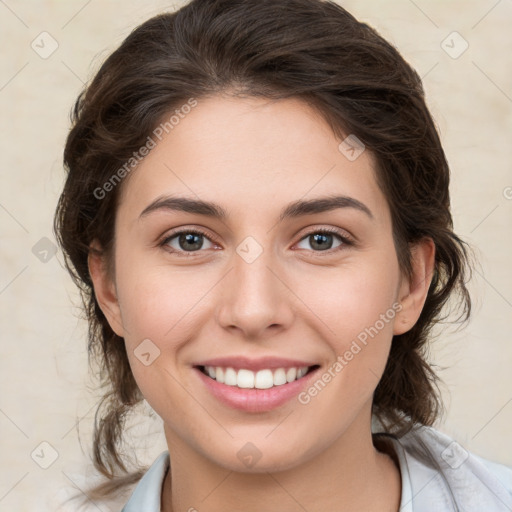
[116,96,387,226]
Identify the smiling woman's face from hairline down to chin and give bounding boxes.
[90,97,428,471]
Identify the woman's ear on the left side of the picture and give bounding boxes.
[88,240,124,337]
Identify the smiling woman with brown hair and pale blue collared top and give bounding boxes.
[56,0,512,512]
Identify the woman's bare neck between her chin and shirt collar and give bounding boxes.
[162,412,401,512]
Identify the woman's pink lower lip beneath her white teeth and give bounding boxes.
[194,368,319,412]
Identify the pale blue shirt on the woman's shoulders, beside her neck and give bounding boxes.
[121,427,512,512]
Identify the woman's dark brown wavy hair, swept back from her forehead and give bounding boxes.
[55,0,471,504]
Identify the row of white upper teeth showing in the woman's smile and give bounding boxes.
[204,366,309,389]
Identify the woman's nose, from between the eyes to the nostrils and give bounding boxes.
[217,247,294,340]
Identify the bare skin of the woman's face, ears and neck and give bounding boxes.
[89,96,434,512]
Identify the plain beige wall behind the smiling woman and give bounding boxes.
[0,0,512,512]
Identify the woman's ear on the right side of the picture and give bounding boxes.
[393,238,436,334]
